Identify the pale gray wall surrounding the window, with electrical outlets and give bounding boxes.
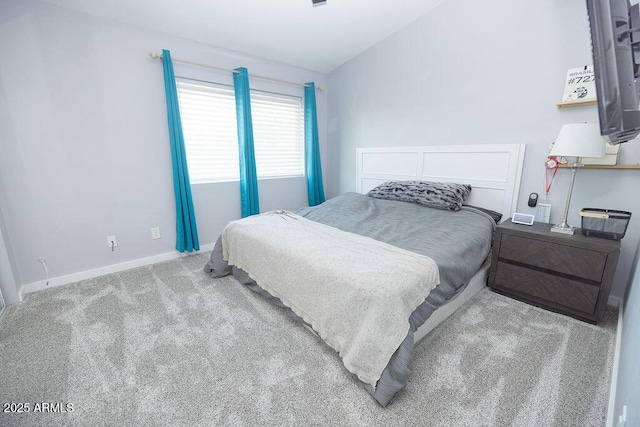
[0,0,327,298]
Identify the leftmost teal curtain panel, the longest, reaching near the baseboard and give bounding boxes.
[162,49,200,252]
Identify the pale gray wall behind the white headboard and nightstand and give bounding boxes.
[328,0,640,297]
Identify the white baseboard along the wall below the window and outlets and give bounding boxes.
[18,243,215,302]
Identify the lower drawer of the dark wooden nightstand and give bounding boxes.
[494,262,600,314]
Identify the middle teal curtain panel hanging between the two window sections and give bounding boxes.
[233,67,260,218]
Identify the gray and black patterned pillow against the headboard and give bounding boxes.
[367,181,471,211]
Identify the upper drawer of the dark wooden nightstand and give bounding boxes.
[500,234,607,282]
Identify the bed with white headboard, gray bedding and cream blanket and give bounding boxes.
[204,144,524,406]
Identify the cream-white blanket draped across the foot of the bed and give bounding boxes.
[222,211,439,387]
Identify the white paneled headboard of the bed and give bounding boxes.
[356,144,525,219]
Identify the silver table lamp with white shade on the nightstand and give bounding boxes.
[549,123,604,234]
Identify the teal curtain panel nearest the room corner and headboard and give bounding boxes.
[304,82,325,206]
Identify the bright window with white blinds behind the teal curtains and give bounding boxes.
[176,78,304,184]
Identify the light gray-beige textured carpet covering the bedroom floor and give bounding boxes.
[0,254,617,426]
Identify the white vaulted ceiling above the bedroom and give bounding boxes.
[37,0,446,73]
